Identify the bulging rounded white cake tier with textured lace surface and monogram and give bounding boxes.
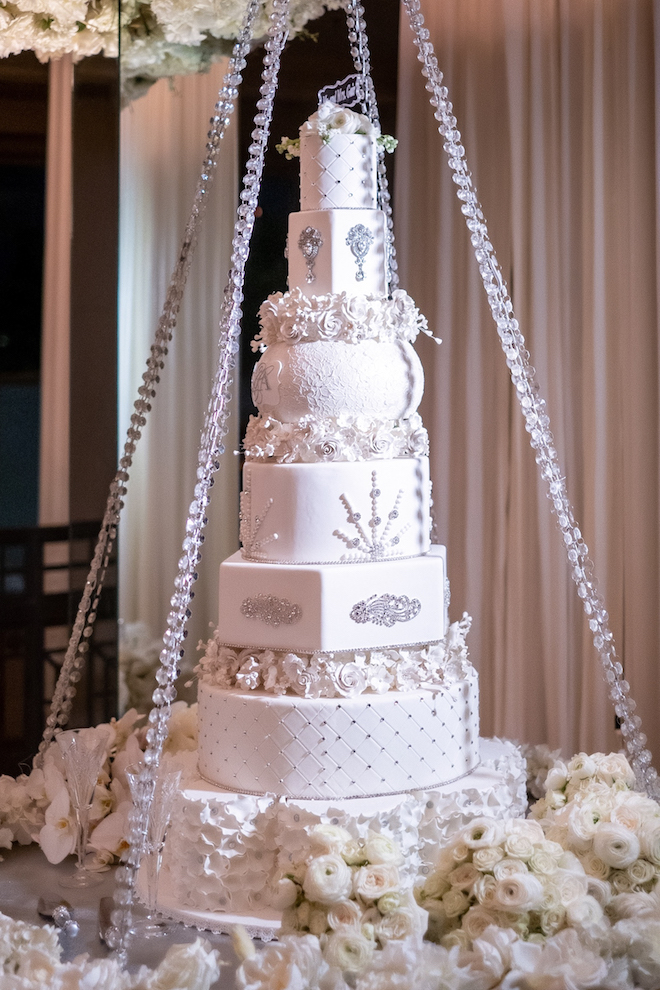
[252,340,424,423]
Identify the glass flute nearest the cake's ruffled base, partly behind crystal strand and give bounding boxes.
[126,763,181,938]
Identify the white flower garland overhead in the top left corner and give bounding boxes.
[0,0,341,101]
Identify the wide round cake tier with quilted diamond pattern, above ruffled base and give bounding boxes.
[197,670,479,799]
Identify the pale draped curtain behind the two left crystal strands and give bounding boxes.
[119,61,238,669]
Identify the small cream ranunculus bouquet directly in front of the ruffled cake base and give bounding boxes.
[272,825,423,973]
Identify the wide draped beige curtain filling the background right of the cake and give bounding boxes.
[396,0,660,766]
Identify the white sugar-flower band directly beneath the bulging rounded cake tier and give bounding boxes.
[244,413,429,464]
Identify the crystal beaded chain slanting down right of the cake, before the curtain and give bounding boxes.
[403,0,660,799]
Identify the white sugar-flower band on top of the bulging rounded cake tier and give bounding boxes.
[252,289,428,350]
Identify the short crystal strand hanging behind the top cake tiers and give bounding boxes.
[346,0,399,293]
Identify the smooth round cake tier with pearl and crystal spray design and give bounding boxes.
[241,457,431,564]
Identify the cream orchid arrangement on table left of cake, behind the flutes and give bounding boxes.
[0,701,197,870]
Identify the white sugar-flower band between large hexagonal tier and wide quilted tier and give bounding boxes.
[195,613,473,698]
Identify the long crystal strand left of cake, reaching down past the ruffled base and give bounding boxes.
[106,0,289,958]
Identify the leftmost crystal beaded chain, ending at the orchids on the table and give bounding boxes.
[37,0,260,762]
